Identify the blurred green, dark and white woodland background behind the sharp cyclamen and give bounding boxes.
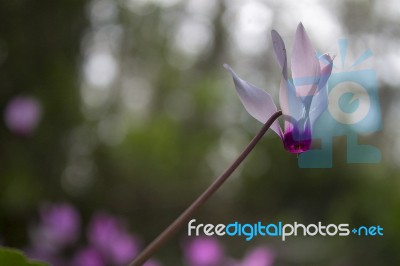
[0,0,400,266]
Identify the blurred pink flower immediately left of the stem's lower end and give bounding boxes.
[88,214,138,265]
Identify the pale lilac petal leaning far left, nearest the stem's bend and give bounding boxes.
[224,64,283,138]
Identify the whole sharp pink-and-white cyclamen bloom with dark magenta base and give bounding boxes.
[224,23,333,154]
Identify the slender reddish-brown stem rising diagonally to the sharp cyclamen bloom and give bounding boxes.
[129,111,282,266]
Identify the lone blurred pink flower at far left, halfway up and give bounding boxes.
[4,96,41,136]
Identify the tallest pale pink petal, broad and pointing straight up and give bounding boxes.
[291,23,320,97]
